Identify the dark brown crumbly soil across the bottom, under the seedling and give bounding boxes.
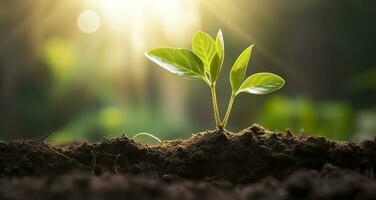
[0,125,376,200]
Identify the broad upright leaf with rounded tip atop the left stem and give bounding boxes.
[192,31,216,73]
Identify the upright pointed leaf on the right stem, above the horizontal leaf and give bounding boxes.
[230,45,253,93]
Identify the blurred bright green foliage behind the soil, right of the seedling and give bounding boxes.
[257,97,353,140]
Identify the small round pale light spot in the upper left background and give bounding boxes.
[77,10,100,33]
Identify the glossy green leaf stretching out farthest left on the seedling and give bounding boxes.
[145,47,205,79]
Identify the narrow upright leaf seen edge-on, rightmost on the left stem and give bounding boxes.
[210,30,225,83]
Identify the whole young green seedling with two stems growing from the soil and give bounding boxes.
[145,30,285,130]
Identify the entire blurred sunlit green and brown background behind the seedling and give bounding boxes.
[0,0,376,142]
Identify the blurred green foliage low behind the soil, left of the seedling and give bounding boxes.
[49,105,190,142]
